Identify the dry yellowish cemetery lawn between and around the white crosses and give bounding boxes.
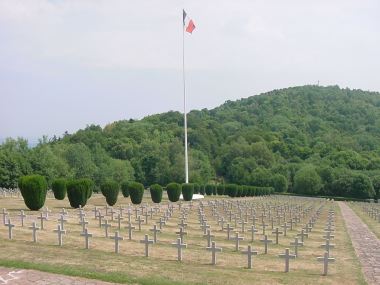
[0,194,366,284]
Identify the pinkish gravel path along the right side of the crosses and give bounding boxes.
[338,202,380,284]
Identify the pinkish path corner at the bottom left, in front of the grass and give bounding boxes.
[0,267,120,285]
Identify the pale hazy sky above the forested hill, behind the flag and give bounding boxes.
[0,0,380,141]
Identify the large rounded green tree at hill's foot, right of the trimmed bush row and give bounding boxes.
[294,166,322,195]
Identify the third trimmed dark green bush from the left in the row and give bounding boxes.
[66,179,91,208]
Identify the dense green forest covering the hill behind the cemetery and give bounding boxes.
[0,86,380,198]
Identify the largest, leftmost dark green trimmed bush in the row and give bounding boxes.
[18,175,47,211]
